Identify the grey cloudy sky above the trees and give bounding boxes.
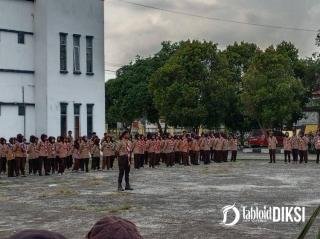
[105,0,320,78]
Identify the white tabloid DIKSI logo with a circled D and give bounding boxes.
[220,204,305,226]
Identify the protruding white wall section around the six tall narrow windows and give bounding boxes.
[36,0,105,135]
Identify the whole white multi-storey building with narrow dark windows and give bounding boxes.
[0,0,105,138]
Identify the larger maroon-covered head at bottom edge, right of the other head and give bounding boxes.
[87,216,143,239]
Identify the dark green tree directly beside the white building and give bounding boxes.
[106,42,178,130]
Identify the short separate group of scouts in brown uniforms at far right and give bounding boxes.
[268,131,320,164]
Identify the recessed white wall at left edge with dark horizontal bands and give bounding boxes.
[0,0,35,138]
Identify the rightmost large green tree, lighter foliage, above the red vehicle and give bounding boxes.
[241,46,305,128]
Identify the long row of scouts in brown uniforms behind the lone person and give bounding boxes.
[0,134,238,177]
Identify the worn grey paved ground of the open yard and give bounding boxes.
[0,154,320,239]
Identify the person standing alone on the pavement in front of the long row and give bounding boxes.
[116,131,133,191]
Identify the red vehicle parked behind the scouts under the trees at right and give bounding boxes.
[248,129,284,148]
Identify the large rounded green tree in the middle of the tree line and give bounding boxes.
[150,41,233,129]
